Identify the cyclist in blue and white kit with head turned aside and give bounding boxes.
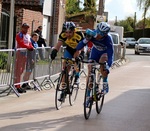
[75,22,114,93]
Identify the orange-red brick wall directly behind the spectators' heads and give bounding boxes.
[15,8,43,34]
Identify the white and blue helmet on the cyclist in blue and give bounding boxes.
[96,22,110,36]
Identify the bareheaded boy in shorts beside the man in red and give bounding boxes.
[22,33,39,90]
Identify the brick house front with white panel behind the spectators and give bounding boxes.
[1,0,65,46]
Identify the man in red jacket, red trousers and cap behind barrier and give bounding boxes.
[14,23,33,93]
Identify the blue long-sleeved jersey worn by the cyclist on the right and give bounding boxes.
[76,31,114,67]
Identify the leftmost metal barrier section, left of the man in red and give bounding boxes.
[0,49,19,96]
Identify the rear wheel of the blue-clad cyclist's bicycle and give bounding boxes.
[96,76,105,114]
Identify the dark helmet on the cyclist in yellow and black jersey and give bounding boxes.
[62,22,76,31]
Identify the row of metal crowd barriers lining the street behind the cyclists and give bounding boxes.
[0,45,125,97]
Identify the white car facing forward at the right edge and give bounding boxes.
[135,38,150,54]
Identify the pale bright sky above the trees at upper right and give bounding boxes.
[81,0,148,21]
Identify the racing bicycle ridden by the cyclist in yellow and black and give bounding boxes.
[55,57,79,110]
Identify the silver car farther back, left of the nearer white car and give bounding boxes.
[124,37,136,48]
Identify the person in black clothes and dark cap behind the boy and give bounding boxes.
[34,26,46,60]
